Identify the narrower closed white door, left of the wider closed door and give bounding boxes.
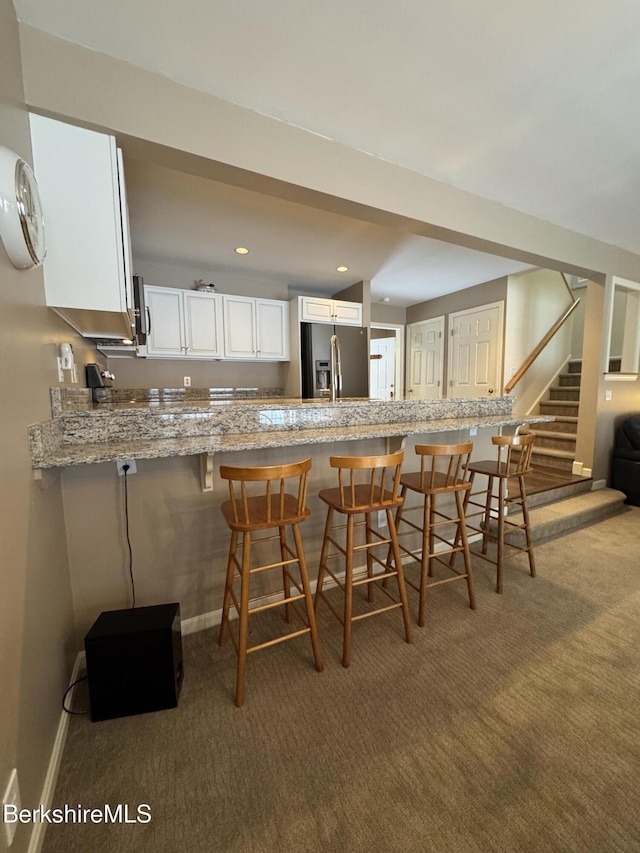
[407,317,444,400]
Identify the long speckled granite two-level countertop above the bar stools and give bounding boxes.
[29,388,553,469]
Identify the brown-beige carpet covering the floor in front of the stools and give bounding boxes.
[44,509,640,853]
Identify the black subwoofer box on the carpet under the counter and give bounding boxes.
[84,604,183,723]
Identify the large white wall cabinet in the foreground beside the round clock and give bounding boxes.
[29,114,133,336]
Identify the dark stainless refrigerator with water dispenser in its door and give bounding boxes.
[300,323,369,399]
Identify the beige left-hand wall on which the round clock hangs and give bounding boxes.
[0,0,100,853]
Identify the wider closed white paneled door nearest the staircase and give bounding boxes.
[449,302,504,397]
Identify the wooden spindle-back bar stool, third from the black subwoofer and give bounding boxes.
[396,441,476,627]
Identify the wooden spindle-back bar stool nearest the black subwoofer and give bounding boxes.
[218,459,323,707]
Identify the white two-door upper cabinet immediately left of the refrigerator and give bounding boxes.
[222,296,289,361]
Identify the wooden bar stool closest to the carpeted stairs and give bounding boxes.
[465,432,536,593]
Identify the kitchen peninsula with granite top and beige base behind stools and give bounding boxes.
[29,389,549,632]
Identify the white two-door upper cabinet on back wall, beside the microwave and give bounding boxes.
[144,286,223,358]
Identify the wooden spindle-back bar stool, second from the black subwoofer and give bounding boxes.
[315,451,412,667]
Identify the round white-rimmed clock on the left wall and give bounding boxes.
[0,146,47,270]
